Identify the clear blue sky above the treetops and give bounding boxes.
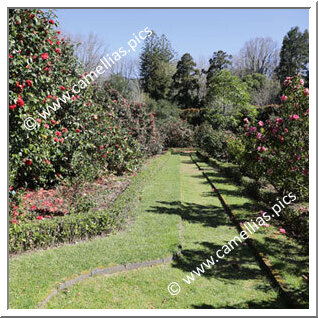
[57,9,309,59]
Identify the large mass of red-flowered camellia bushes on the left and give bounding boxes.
[9,9,162,224]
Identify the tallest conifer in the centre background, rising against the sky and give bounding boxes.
[140,31,175,100]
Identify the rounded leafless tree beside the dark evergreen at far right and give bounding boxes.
[233,38,279,77]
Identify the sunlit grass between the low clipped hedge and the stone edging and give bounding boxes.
[9,154,180,309]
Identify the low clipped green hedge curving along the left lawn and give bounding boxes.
[9,152,171,253]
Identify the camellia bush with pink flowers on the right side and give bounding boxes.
[228,76,309,200]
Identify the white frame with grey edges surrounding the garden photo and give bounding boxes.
[0,0,316,316]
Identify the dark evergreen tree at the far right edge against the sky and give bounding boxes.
[277,27,309,83]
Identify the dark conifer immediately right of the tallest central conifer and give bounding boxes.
[172,53,199,108]
